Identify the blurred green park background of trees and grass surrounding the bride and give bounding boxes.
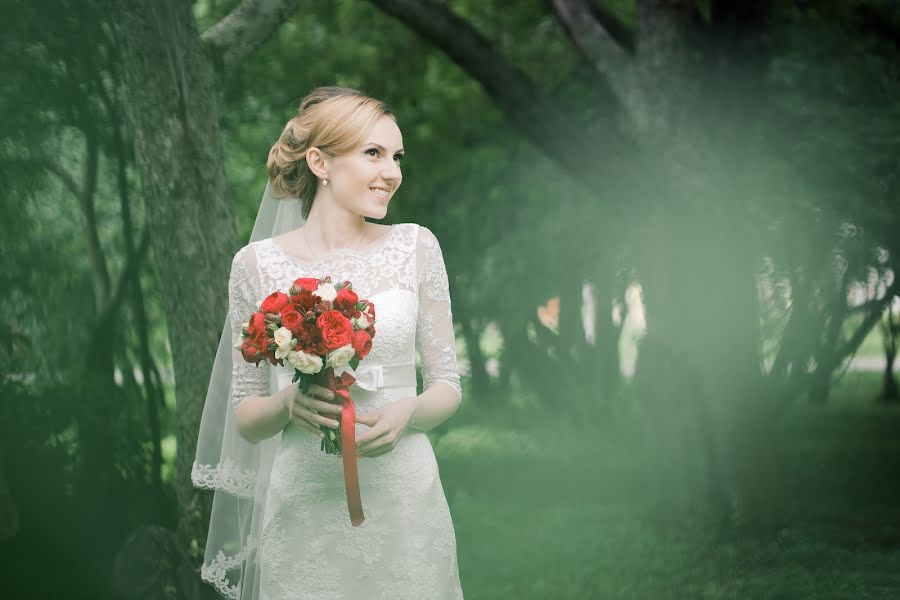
[0,0,900,600]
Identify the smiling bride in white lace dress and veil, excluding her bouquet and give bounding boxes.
[192,87,463,600]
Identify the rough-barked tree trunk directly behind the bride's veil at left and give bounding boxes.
[110,0,238,558]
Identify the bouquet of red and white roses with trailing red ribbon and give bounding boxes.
[235,276,375,525]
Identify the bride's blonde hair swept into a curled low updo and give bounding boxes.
[266,86,397,219]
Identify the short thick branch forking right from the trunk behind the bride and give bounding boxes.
[200,0,300,73]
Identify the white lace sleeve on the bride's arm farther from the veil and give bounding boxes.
[416,226,462,398]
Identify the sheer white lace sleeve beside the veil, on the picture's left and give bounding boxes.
[228,246,269,407]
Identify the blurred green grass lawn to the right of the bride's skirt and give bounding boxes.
[435,373,900,600]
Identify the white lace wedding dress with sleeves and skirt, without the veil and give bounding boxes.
[230,223,463,600]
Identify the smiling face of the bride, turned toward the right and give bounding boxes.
[316,115,403,219]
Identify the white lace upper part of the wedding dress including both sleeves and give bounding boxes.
[228,223,462,406]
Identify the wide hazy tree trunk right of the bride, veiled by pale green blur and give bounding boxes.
[622,0,778,536]
